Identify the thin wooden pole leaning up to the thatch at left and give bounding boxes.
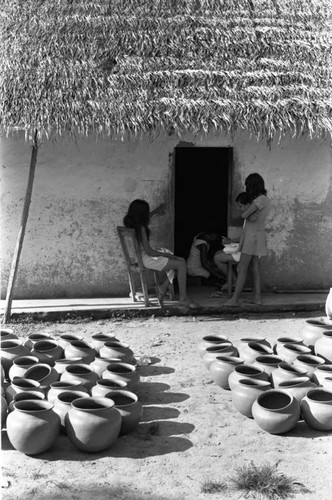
[3,130,38,323]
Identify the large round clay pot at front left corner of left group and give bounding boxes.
[7,400,60,455]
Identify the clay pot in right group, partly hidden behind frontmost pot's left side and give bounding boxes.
[232,378,271,418]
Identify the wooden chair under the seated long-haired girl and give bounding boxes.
[116,226,174,307]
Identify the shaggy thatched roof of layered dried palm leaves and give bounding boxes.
[0,0,332,139]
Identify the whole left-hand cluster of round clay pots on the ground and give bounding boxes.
[1,330,142,455]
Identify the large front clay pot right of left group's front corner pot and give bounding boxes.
[65,397,121,453]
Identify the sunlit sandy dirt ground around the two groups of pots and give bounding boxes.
[1,313,332,500]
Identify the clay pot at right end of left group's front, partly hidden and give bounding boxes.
[105,389,143,434]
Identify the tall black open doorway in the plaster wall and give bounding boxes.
[174,147,232,258]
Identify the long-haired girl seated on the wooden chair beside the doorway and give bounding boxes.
[123,200,199,309]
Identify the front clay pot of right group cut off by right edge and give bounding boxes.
[301,387,332,431]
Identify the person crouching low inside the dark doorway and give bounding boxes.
[187,232,223,281]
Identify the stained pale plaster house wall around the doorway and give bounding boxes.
[0,134,332,298]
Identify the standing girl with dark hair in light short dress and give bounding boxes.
[224,173,270,306]
